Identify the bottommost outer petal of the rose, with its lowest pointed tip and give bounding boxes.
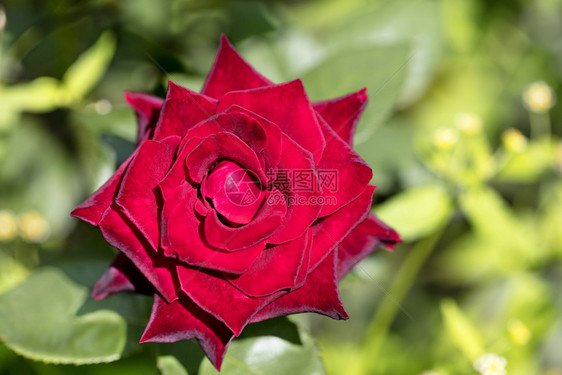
[140,294,234,370]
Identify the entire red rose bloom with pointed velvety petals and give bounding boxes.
[72,37,400,368]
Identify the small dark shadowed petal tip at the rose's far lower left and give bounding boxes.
[91,253,154,300]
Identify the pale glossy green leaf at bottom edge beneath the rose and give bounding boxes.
[200,331,325,375]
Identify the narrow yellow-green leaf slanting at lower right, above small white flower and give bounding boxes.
[441,300,484,362]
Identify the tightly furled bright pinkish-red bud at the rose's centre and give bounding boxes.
[203,160,265,224]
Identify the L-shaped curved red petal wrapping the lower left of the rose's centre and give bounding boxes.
[161,184,265,274]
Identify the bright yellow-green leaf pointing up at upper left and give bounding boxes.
[62,32,116,102]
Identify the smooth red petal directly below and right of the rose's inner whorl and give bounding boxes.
[227,229,312,297]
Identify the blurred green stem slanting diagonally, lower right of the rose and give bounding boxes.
[362,230,442,374]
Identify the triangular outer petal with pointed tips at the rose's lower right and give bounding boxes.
[252,249,348,323]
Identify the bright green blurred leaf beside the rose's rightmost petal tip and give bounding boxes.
[375,185,453,241]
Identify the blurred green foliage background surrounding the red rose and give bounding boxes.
[0,0,562,375]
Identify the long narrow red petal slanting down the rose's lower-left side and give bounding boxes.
[99,207,178,302]
